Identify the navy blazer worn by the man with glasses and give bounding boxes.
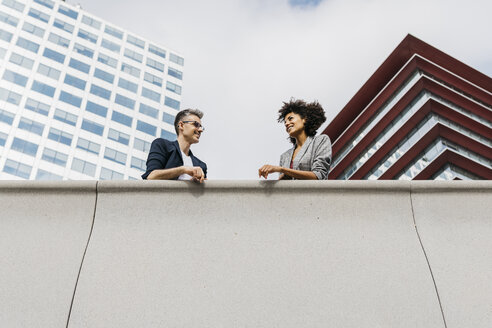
[142,138,207,180]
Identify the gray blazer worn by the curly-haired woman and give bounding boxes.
[280,134,331,180]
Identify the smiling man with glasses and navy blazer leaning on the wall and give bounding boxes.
[142,109,207,183]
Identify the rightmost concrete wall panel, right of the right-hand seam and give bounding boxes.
[412,182,492,328]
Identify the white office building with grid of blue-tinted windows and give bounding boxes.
[0,0,184,180]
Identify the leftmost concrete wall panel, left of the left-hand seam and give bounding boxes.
[0,181,96,328]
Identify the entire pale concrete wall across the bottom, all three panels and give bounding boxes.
[0,181,492,327]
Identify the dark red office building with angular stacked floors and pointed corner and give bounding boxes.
[323,35,492,180]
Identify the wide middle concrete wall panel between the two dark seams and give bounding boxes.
[70,181,443,327]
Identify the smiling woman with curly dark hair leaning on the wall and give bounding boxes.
[258,99,331,180]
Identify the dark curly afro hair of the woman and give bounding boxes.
[278,99,326,143]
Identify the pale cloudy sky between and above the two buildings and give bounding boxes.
[78,0,492,180]
